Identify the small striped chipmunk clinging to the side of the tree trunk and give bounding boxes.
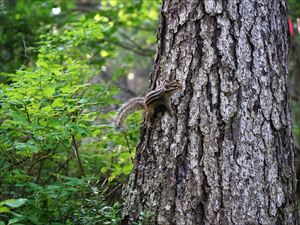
[116,80,182,129]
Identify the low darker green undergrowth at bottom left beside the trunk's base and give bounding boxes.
[0,177,121,224]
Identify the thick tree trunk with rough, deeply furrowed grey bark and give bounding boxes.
[123,0,298,225]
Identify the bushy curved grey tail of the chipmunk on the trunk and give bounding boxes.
[115,97,144,129]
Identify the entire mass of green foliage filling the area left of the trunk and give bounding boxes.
[0,0,159,225]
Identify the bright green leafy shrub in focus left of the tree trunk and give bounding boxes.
[0,13,137,224]
